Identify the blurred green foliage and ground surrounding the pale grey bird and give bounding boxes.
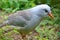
[0,0,60,40]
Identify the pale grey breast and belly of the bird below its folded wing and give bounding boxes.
[13,15,40,34]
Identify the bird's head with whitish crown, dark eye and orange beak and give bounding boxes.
[33,4,54,19]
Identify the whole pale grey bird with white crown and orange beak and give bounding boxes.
[0,4,54,38]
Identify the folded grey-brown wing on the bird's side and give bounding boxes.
[8,11,31,27]
